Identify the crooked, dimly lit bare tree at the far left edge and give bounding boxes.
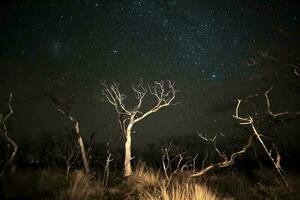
[0,93,18,172]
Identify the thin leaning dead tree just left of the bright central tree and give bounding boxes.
[50,95,90,174]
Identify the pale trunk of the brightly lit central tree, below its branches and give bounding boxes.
[124,124,132,177]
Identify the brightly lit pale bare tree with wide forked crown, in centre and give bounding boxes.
[102,81,177,177]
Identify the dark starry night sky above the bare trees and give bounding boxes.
[0,0,300,148]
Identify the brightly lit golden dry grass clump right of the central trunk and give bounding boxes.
[126,163,218,200]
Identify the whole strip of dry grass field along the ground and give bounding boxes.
[0,164,300,200]
